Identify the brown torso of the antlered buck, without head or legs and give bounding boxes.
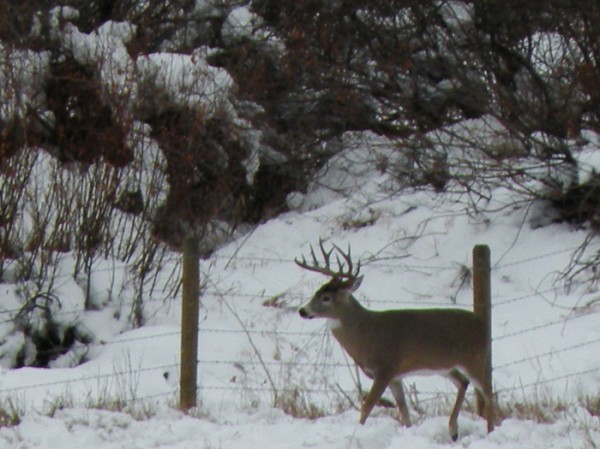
[332,300,485,377]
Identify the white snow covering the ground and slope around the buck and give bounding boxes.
[0,145,600,449]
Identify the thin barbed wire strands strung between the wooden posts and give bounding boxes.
[0,248,600,416]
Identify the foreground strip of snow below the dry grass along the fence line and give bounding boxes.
[0,409,598,449]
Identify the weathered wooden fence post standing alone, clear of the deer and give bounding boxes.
[179,237,200,411]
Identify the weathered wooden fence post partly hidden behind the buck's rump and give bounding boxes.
[473,245,492,415]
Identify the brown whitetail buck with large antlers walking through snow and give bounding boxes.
[296,240,494,441]
